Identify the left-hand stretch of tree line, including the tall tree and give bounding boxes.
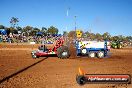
[0,17,58,36]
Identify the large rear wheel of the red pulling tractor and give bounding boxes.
[57,46,70,59]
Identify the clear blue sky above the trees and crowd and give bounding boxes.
[0,0,132,36]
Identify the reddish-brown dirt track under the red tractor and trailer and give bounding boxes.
[0,45,132,88]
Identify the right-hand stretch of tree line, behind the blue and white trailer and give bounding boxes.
[66,31,132,42]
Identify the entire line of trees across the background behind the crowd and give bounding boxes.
[0,17,132,42]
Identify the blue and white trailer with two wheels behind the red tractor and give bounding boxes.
[76,41,110,58]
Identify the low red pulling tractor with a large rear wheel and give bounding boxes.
[31,38,70,59]
